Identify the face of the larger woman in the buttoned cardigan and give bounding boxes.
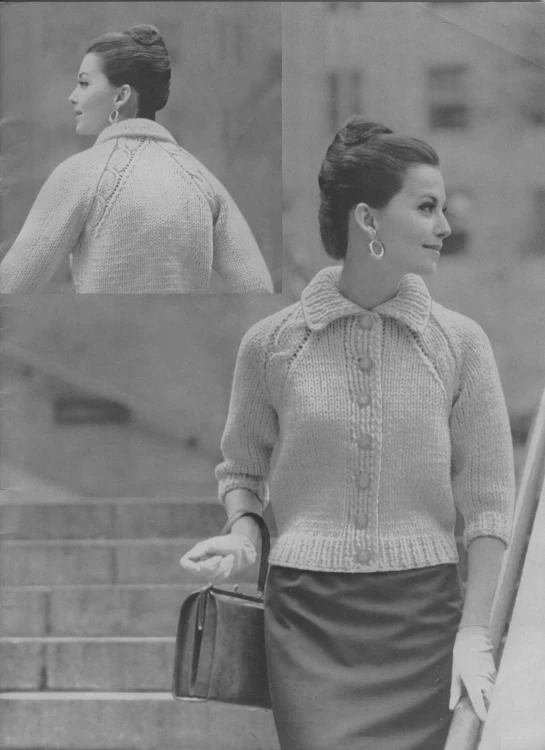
[370,164,450,275]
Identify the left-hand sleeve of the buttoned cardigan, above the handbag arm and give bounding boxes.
[216,327,278,505]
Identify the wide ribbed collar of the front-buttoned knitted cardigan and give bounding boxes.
[301,266,431,333]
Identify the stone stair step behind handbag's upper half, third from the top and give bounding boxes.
[0,583,255,636]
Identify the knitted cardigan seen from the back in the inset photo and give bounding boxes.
[0,118,273,294]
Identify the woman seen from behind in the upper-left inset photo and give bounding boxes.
[0,25,273,294]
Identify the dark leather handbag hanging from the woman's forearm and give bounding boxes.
[172,511,271,708]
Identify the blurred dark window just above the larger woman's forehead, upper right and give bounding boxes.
[428,65,469,129]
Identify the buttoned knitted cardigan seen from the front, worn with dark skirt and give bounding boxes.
[216,267,514,572]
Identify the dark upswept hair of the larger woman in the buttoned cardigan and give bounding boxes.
[318,115,439,260]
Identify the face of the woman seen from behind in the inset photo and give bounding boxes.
[68,52,119,135]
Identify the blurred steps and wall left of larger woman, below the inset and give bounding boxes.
[0,294,282,750]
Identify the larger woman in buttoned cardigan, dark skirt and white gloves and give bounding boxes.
[181,117,514,750]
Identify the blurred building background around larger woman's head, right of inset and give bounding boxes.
[282,2,545,439]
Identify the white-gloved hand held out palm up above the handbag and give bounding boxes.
[180,531,257,583]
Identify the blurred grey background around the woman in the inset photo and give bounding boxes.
[0,2,282,291]
